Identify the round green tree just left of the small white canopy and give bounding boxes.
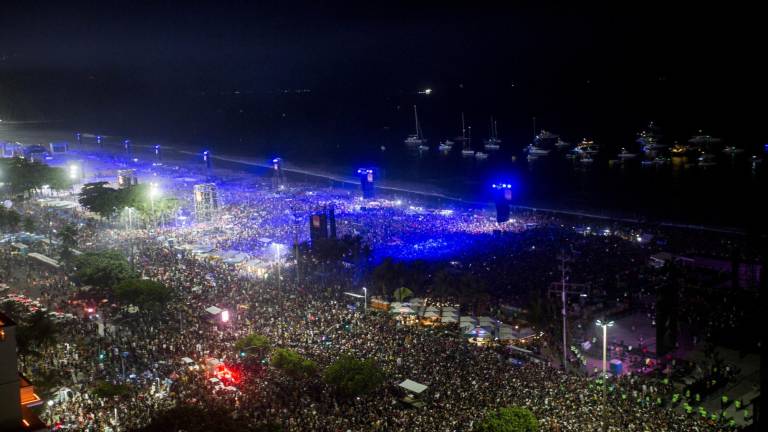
[323,355,384,397]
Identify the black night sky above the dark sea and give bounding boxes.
[0,2,766,146]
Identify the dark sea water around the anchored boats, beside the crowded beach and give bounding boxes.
[3,86,768,227]
